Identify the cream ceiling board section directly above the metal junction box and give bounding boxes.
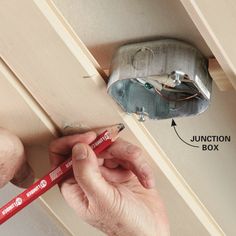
[53,0,211,69]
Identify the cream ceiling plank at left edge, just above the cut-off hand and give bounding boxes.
[0,60,51,145]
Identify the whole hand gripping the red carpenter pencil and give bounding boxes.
[49,132,169,236]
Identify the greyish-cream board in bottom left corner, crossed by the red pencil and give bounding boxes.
[0,184,70,236]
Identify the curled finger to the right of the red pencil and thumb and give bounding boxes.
[100,140,155,188]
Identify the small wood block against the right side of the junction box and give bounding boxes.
[208,58,233,91]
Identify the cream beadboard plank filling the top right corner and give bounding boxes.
[181,0,236,89]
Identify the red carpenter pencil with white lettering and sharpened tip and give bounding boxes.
[0,124,124,225]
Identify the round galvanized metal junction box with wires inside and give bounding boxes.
[108,39,212,121]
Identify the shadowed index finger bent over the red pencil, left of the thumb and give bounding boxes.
[49,131,97,168]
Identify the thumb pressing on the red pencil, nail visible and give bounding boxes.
[72,144,112,199]
